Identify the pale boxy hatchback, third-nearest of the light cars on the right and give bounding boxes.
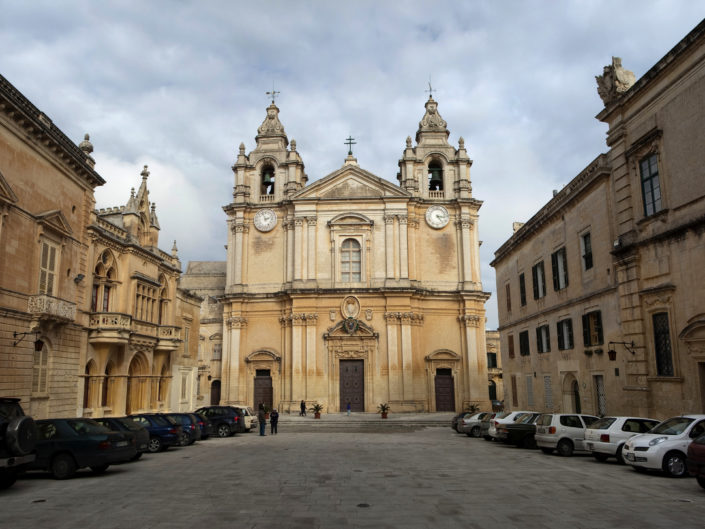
[534,413,597,456]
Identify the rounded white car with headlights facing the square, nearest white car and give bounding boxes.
[622,415,705,477]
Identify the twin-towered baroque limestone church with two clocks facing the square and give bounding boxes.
[187,97,490,412]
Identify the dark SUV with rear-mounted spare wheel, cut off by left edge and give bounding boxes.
[0,397,37,489]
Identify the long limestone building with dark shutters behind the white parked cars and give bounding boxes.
[493,21,705,418]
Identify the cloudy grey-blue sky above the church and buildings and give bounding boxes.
[0,0,705,328]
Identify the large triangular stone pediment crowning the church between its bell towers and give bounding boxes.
[293,165,411,200]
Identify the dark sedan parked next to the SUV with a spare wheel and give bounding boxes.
[29,418,137,479]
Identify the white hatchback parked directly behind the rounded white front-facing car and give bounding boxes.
[585,417,659,464]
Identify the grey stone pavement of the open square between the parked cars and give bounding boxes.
[0,423,705,529]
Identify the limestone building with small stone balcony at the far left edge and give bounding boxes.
[0,76,104,418]
